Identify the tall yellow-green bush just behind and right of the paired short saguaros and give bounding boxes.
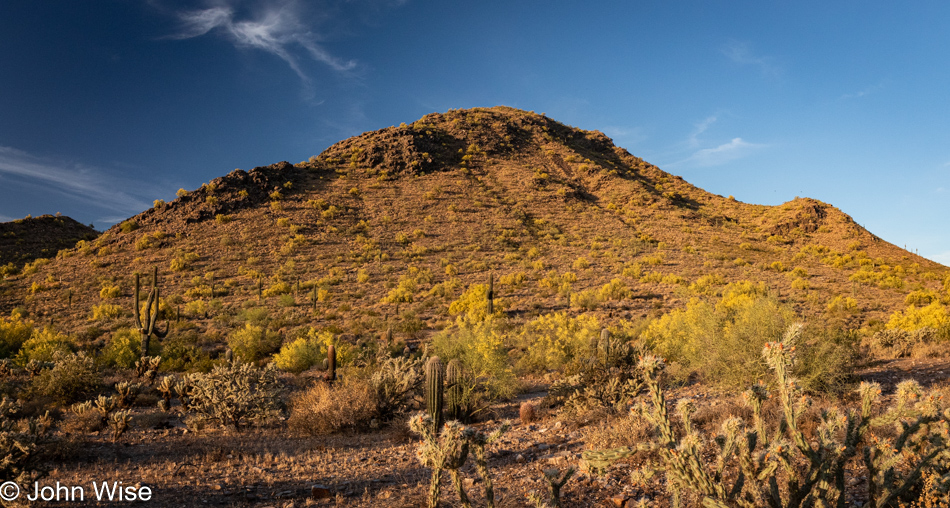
[432,316,517,407]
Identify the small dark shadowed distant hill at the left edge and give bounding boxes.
[0,215,99,267]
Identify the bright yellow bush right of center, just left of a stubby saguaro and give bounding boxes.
[515,312,600,372]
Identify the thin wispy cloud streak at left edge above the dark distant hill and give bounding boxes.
[0,146,157,217]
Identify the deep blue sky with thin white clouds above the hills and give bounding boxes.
[0,0,950,265]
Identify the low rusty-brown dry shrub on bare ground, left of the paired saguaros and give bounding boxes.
[287,377,376,435]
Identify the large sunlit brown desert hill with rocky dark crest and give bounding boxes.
[0,107,950,345]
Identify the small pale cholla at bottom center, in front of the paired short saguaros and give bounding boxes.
[409,413,510,508]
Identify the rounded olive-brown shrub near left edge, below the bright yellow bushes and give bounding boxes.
[32,351,101,404]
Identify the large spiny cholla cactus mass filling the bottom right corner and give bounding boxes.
[585,324,950,508]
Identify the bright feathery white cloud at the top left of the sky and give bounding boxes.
[169,0,356,85]
